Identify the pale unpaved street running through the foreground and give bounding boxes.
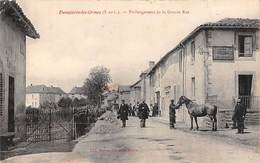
[3,117,260,163]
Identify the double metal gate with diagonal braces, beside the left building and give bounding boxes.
[26,108,74,142]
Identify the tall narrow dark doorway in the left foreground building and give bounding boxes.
[8,76,15,132]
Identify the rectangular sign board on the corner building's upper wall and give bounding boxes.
[212,46,234,60]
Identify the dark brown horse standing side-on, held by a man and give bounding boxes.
[178,96,217,131]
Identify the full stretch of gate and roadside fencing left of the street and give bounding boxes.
[26,107,104,143]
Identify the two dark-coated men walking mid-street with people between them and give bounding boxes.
[117,100,150,127]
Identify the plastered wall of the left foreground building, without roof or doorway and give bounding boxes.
[0,15,26,135]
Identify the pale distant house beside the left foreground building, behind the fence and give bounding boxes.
[26,85,66,108]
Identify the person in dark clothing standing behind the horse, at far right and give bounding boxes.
[233,98,246,134]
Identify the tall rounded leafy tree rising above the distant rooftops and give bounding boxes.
[83,66,112,106]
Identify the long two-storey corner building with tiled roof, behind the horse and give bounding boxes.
[148,18,260,126]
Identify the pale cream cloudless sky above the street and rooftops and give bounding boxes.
[17,0,260,92]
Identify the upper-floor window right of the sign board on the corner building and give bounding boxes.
[238,35,253,57]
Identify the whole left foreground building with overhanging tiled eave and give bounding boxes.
[0,0,39,137]
